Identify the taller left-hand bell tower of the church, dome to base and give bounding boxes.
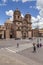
[13,9,21,38]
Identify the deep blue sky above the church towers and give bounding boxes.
[0,0,43,28]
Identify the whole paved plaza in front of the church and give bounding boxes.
[0,39,43,65]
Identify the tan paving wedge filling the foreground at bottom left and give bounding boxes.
[0,47,42,65]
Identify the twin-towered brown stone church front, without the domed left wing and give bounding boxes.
[13,10,32,39]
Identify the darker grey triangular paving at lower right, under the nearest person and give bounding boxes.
[18,47,43,65]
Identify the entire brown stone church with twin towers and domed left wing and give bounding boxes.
[0,9,32,39]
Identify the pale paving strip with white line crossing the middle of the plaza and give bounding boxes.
[5,44,32,53]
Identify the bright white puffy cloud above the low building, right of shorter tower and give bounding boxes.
[31,15,43,28]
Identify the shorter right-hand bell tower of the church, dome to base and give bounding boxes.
[25,13,32,38]
